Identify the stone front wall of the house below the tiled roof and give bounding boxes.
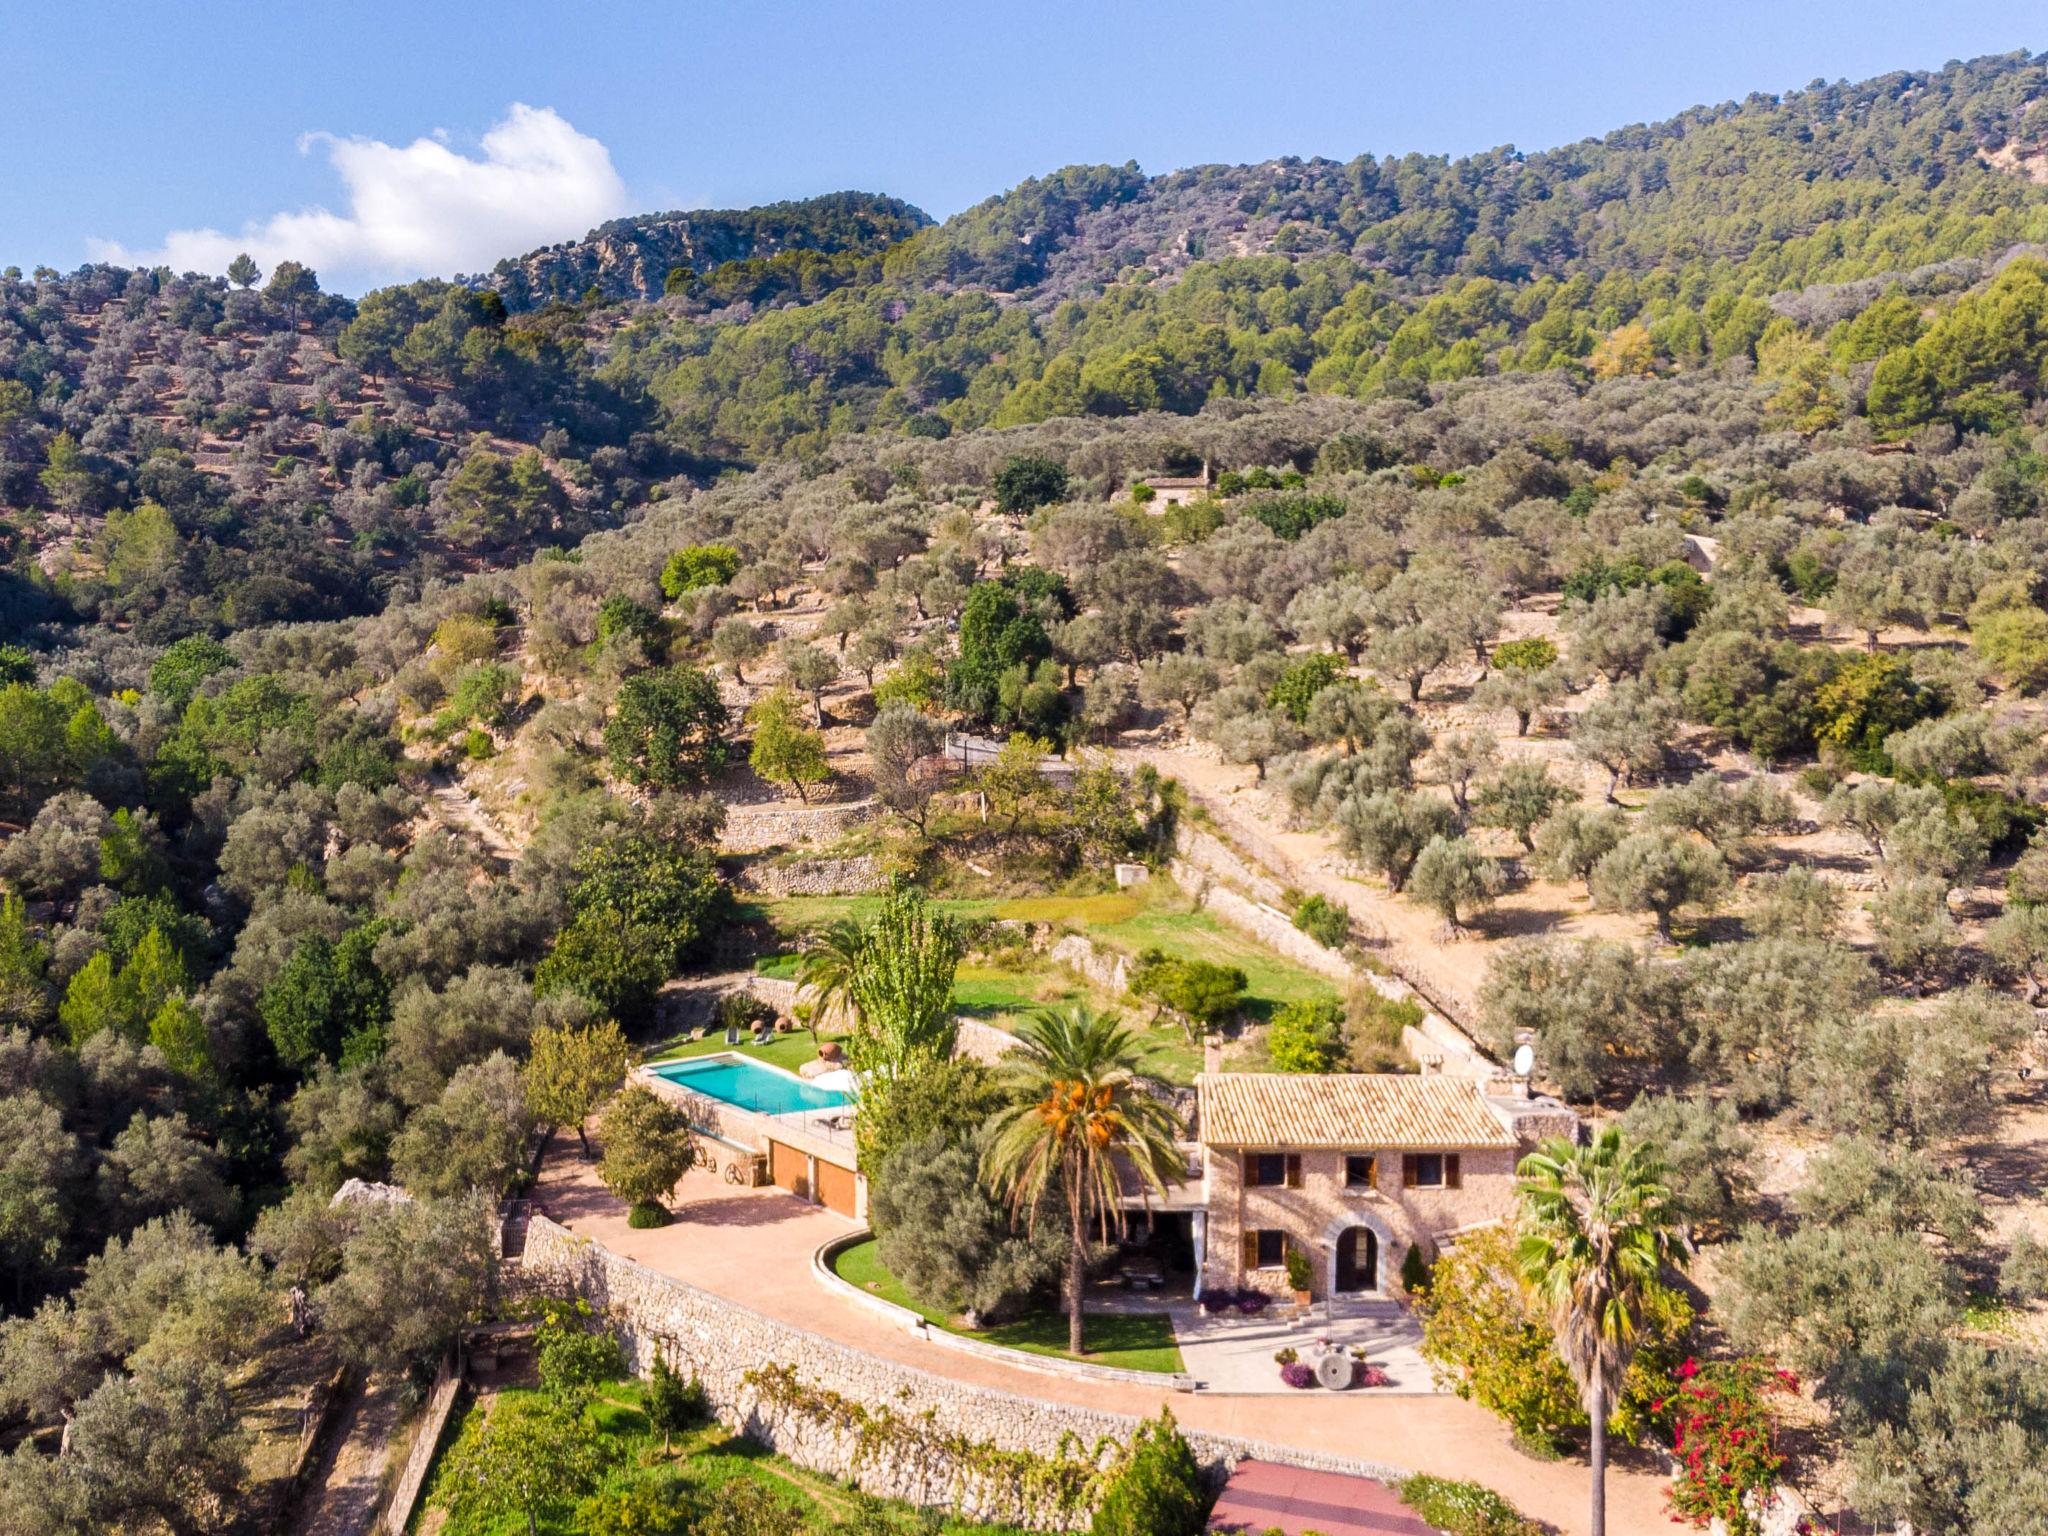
[1202,1147,1520,1298]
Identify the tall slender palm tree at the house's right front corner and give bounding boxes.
[1516,1126,1686,1536]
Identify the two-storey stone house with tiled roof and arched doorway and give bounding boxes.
[1196,1071,1579,1298]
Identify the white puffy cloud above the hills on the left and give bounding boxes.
[88,102,627,291]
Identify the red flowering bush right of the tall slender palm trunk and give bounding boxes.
[1653,1360,1798,1536]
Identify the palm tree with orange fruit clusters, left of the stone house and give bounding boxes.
[981,1008,1188,1356]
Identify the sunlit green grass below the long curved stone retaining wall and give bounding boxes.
[412,1380,1016,1536]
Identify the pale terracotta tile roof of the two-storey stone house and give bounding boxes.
[1196,1071,1516,1149]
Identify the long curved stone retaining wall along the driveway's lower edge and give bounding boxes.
[524,1217,1405,1530]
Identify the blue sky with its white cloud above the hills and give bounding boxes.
[0,0,2048,291]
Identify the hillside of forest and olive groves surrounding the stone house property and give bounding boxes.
[0,41,2048,1536]
